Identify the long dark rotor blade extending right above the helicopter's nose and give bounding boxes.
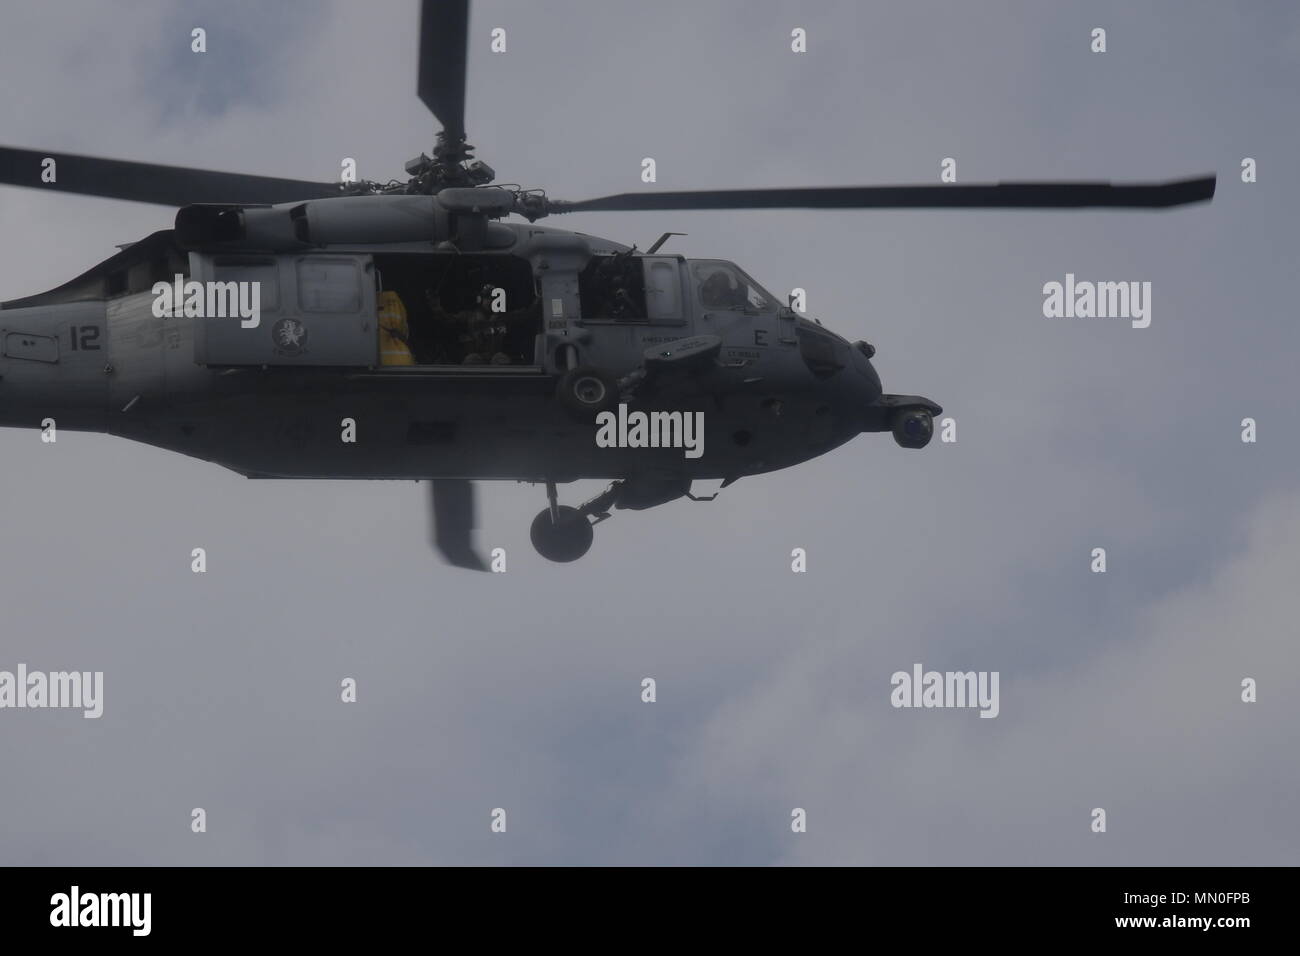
[549,176,1214,213]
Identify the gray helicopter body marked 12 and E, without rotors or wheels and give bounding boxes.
[0,196,915,481]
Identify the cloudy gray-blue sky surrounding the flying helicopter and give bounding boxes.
[0,0,1300,865]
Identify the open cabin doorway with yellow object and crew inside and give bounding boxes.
[374,252,542,365]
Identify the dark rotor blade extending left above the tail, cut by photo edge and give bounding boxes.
[0,146,339,206]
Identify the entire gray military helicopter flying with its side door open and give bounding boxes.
[0,0,1216,570]
